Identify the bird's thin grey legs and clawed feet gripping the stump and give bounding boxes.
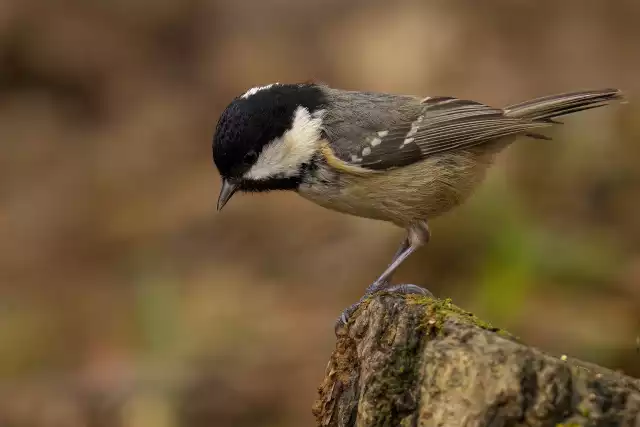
[335,221,433,333]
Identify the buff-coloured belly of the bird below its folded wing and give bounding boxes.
[299,152,493,227]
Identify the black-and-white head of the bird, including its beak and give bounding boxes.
[213,83,325,210]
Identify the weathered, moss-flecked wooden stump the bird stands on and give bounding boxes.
[313,294,640,427]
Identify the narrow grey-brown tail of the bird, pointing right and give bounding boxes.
[504,89,623,122]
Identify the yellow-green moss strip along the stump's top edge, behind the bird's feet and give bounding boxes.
[407,295,518,341]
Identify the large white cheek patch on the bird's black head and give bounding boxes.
[244,106,324,179]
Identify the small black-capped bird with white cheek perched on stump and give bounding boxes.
[212,82,623,333]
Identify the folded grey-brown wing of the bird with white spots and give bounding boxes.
[329,97,550,170]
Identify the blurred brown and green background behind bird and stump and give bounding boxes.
[0,0,640,427]
